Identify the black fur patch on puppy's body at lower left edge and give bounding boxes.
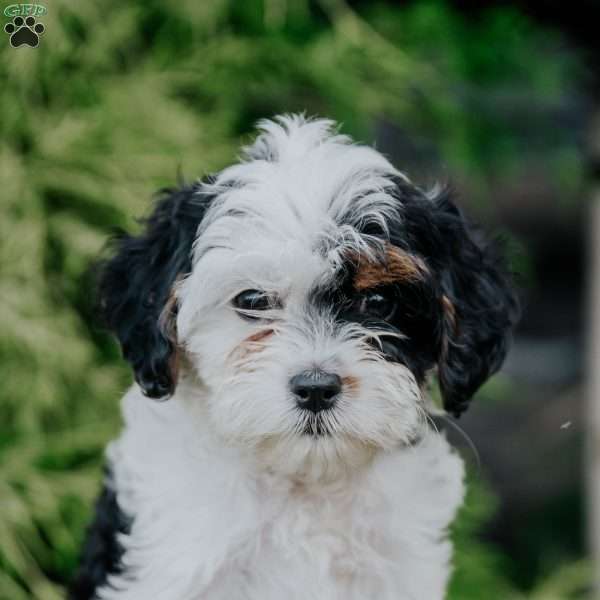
[68,473,131,600]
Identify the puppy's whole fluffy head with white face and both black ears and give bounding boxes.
[100,117,517,470]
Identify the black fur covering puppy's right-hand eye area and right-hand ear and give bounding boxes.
[311,180,519,416]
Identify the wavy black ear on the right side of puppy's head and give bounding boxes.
[426,190,519,416]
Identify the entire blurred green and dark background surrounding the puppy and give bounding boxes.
[0,0,600,600]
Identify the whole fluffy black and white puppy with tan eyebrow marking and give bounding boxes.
[71,116,517,600]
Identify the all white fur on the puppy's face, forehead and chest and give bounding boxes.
[99,116,463,600]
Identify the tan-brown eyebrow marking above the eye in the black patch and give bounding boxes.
[354,244,428,291]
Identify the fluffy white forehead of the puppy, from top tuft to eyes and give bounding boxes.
[177,115,404,322]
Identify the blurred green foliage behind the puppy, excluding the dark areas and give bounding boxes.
[0,0,578,600]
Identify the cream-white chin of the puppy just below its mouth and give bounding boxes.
[254,434,381,483]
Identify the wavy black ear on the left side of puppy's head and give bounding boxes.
[98,184,210,398]
